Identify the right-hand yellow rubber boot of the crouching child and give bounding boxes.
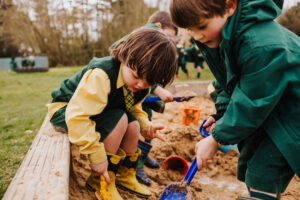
[116,149,151,198]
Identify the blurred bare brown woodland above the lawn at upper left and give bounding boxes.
[0,0,162,66]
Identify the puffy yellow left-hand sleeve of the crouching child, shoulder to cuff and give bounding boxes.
[66,68,110,164]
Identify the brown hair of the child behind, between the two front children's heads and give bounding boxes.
[148,11,177,33]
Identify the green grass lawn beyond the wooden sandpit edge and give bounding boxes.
[0,63,213,199]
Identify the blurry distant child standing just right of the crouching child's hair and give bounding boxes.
[176,37,190,80]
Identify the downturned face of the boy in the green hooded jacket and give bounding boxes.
[188,15,228,48]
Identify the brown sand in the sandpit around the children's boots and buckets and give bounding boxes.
[69,91,300,200]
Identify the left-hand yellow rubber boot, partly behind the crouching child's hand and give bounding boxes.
[87,149,126,200]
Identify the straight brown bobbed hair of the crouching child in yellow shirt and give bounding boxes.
[111,28,177,87]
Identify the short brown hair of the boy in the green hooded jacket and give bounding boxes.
[170,0,234,28]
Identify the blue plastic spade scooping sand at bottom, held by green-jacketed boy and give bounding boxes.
[159,158,198,200]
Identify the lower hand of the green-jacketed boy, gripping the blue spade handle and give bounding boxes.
[195,135,218,170]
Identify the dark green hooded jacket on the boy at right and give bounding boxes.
[197,0,300,176]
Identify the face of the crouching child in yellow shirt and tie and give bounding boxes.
[122,65,151,92]
